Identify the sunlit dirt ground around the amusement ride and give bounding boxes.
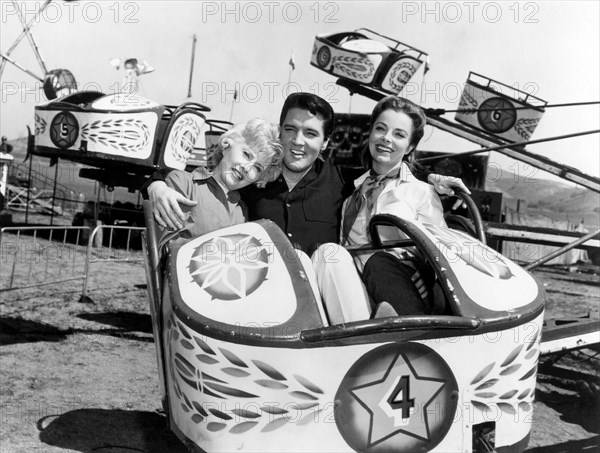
[0,230,600,453]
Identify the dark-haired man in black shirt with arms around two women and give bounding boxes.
[144,93,464,256]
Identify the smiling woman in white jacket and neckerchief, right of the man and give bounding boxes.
[313,96,446,324]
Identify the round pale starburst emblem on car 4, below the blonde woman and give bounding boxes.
[189,234,269,300]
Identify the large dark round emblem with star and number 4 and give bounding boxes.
[334,343,458,453]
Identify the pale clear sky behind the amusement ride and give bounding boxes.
[0,0,600,178]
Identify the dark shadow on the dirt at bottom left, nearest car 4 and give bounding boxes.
[37,409,188,453]
